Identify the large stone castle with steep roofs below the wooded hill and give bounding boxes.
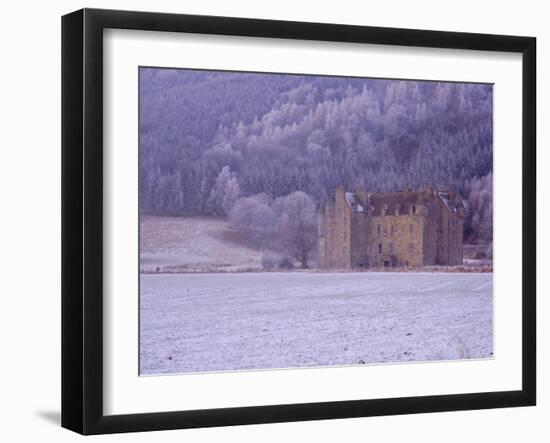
[318,186,464,269]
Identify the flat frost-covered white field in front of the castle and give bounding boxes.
[140,272,493,374]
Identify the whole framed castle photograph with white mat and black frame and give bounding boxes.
[62,9,536,434]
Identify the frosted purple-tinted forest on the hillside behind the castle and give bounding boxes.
[139,68,493,244]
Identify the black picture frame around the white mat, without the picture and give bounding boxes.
[62,9,536,434]
